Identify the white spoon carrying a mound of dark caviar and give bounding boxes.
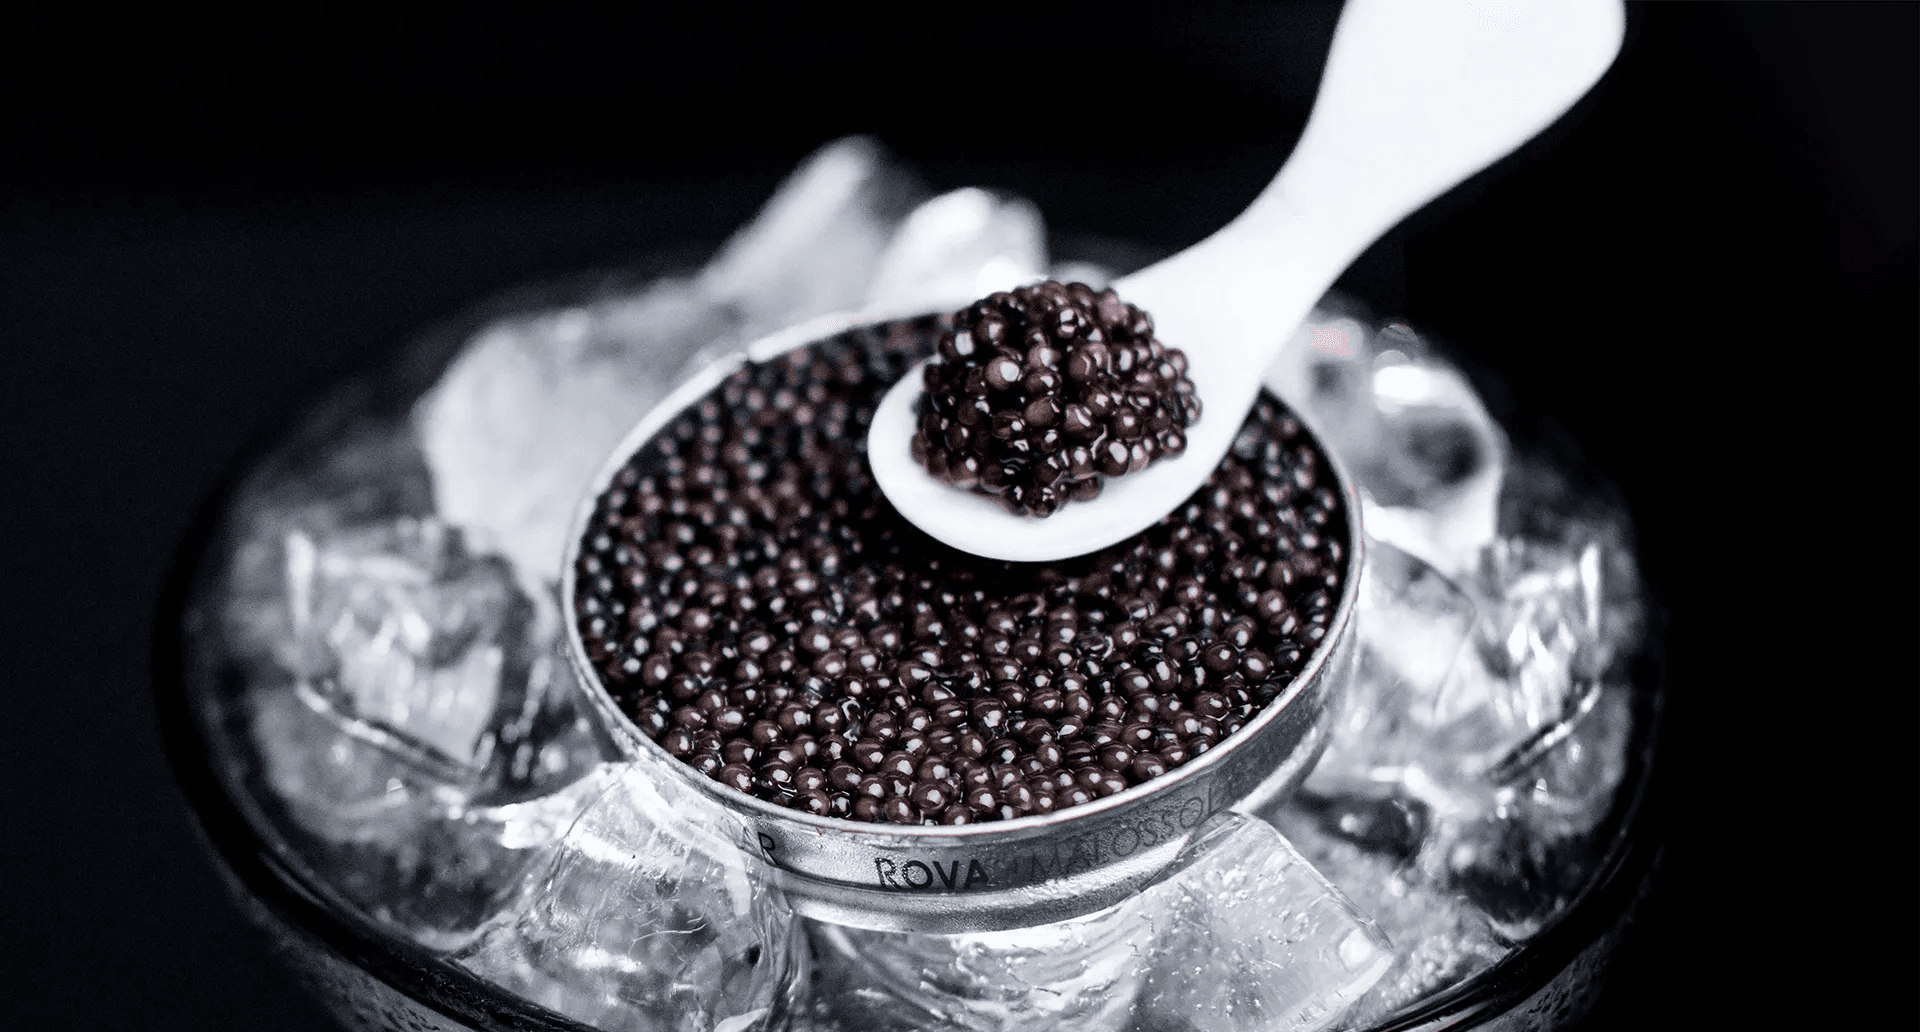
[868,0,1624,562]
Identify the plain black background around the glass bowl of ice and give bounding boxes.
[0,2,1920,1030]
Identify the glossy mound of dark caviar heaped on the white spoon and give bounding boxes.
[912,282,1200,516]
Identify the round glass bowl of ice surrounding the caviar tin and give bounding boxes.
[159,140,1663,1032]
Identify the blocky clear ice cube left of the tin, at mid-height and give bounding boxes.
[227,506,607,804]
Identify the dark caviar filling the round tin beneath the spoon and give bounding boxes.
[574,318,1350,825]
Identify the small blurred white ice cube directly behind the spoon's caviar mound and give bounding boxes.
[866,186,1046,313]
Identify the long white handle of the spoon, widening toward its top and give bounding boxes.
[1117,0,1624,381]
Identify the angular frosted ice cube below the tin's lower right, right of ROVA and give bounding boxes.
[1135,813,1394,1032]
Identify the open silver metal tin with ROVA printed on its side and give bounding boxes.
[561,306,1363,932]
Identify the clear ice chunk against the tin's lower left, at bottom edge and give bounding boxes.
[453,758,810,1032]
